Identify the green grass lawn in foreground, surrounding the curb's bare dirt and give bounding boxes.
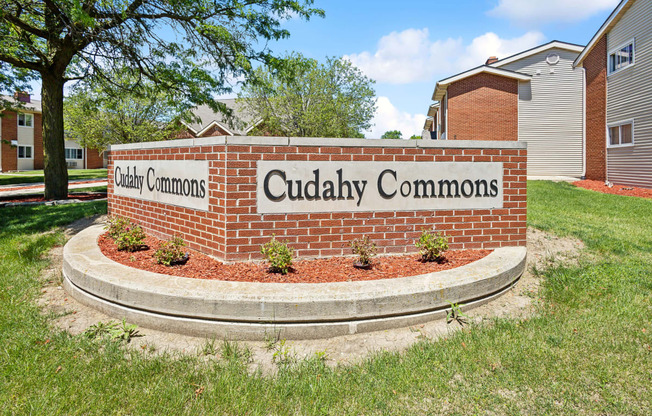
[0,182,652,415]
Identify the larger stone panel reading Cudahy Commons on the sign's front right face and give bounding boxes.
[256,161,503,214]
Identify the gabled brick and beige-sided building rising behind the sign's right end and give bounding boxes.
[424,41,584,177]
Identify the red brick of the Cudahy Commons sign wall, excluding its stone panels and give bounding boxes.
[108,144,527,261]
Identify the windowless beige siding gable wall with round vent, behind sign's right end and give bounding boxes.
[501,48,584,177]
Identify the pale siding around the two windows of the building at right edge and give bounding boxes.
[607,0,652,187]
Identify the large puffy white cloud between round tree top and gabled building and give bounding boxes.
[344,28,545,84]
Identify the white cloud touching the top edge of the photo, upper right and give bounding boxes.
[487,0,620,26]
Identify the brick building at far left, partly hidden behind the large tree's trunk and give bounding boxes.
[0,93,106,172]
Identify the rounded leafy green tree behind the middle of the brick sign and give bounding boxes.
[239,54,376,137]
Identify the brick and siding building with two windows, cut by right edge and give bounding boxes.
[574,0,652,188]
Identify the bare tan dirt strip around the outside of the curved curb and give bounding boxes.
[39,223,583,374]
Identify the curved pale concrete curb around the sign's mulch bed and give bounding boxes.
[63,225,526,339]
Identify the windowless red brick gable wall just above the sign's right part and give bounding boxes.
[447,74,518,140]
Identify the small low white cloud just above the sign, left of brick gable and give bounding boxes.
[366,97,426,139]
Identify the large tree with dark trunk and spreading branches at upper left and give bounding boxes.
[0,0,323,198]
